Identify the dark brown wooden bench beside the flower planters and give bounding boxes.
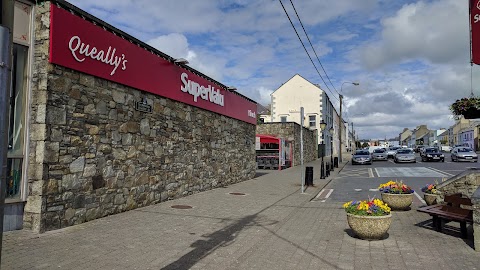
[417,194,473,238]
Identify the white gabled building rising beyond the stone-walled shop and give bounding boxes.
[265,74,338,155]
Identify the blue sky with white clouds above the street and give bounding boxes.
[68,0,480,139]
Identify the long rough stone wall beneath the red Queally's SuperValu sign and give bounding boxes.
[24,2,256,232]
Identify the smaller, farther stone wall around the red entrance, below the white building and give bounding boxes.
[256,122,317,166]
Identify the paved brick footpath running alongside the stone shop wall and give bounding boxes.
[1,156,480,269]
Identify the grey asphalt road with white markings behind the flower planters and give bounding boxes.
[316,153,480,206]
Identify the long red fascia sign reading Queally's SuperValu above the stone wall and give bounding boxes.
[50,5,257,124]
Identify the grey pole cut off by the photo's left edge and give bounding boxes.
[0,0,14,264]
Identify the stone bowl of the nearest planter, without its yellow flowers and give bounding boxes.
[347,213,392,240]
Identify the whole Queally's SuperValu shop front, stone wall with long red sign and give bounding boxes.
[7,1,256,232]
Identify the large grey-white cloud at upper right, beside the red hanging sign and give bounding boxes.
[360,0,469,68]
